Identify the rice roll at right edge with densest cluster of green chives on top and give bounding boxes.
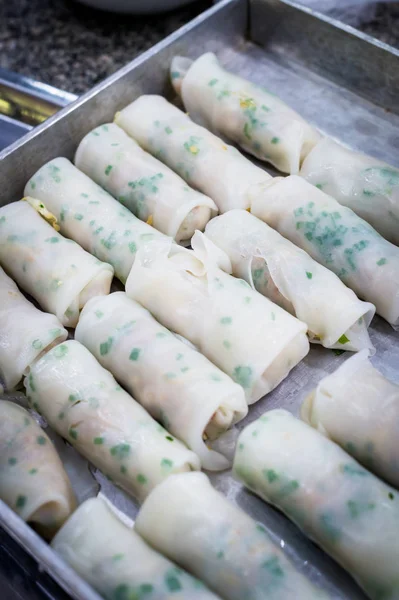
[251,175,399,328]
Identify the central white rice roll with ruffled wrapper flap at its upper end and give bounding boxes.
[126,232,309,404]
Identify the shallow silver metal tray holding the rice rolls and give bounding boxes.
[0,0,399,600]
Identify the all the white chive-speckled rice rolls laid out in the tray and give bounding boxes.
[0,53,399,600]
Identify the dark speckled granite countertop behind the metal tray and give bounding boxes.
[0,0,399,94]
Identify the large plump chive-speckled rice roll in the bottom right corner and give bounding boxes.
[233,410,399,600]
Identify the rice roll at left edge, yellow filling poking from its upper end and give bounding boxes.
[0,199,114,327]
